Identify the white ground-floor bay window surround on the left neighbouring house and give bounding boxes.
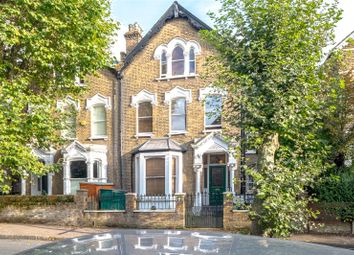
[62,141,108,194]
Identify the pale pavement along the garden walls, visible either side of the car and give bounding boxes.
[0,223,354,250]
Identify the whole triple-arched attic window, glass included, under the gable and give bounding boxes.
[154,37,201,80]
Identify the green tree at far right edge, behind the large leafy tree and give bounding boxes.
[323,43,354,173]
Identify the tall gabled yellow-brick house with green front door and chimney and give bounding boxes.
[118,2,251,203]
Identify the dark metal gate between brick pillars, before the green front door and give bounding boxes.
[185,192,224,228]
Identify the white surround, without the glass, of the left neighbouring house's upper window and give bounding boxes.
[86,93,111,140]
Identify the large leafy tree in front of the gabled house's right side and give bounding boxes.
[203,0,341,236]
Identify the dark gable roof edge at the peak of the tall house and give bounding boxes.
[120,1,211,71]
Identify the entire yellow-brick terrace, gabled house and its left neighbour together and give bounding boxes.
[14,2,254,203]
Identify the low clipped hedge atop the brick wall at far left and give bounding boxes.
[0,195,74,210]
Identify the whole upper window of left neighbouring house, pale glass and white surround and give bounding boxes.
[86,93,111,140]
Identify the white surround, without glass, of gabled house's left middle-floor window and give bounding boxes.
[130,89,157,137]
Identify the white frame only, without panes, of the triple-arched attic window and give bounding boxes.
[154,37,201,80]
